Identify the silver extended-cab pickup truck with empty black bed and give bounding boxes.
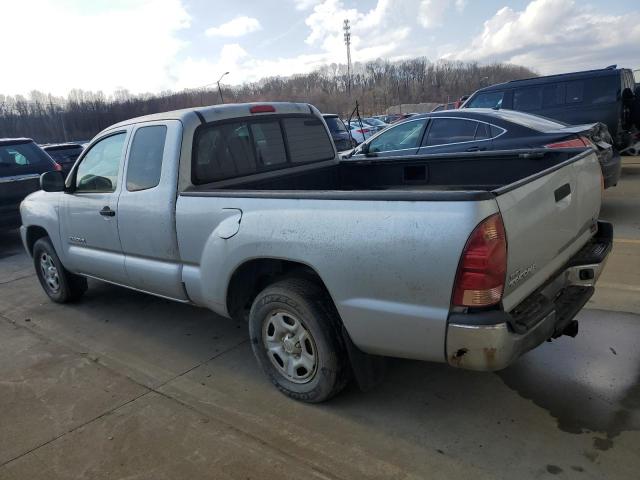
[21,103,612,402]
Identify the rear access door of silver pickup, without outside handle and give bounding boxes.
[118,120,187,300]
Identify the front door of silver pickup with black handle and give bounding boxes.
[60,130,129,284]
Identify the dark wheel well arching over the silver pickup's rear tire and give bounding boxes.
[227,258,331,319]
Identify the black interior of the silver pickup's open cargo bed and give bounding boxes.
[188,150,576,196]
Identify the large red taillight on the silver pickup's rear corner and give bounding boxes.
[453,213,507,307]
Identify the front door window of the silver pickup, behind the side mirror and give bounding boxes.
[76,132,126,193]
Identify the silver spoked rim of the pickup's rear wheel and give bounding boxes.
[262,311,318,383]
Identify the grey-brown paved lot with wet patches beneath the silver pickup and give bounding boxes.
[0,158,640,479]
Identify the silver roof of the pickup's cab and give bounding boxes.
[105,102,320,131]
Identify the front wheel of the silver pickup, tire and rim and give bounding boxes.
[33,237,87,303]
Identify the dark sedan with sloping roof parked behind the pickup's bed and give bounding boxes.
[351,108,621,188]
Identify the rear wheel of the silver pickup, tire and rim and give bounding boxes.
[249,278,351,403]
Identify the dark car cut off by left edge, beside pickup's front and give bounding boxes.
[0,138,61,230]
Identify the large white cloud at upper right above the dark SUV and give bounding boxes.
[445,0,640,73]
